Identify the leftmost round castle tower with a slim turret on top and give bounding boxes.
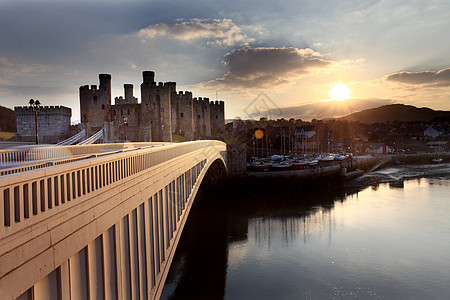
[80,74,111,128]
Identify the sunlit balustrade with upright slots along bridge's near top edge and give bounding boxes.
[0,141,224,240]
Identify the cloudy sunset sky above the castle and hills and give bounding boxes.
[0,0,450,120]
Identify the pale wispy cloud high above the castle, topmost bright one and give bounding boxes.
[138,18,252,46]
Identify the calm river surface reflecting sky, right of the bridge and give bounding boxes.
[162,164,450,299]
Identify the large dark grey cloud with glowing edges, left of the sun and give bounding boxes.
[204,47,332,88]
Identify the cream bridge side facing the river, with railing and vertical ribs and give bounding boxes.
[0,141,226,299]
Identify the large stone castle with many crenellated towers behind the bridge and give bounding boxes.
[80,71,225,142]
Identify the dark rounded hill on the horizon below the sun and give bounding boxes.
[338,104,450,123]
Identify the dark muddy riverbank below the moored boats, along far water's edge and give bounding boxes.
[206,153,450,199]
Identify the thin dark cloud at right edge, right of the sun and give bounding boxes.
[386,68,450,87]
